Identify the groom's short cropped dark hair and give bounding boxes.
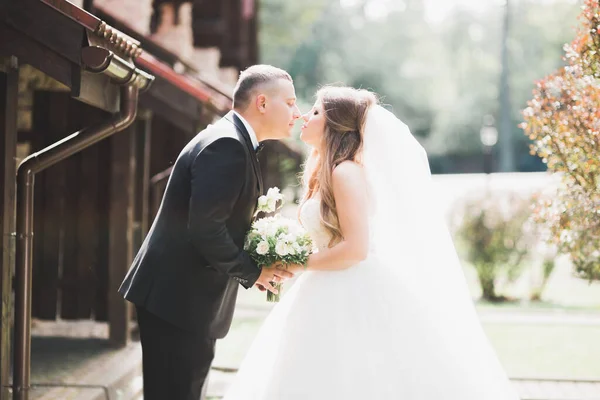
[233,64,293,110]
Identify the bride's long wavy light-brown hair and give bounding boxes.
[301,86,378,247]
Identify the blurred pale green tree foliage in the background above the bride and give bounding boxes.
[260,0,578,172]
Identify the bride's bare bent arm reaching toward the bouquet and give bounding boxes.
[306,161,369,271]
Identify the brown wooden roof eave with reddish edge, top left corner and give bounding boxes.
[0,0,231,119]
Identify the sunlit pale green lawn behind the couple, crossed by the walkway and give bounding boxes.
[219,234,600,379]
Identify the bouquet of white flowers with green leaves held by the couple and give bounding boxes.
[244,188,313,302]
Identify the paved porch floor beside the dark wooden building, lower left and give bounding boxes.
[30,320,142,400]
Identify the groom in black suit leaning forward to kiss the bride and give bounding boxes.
[119,65,300,400]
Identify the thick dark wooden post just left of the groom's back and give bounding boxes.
[108,123,137,346]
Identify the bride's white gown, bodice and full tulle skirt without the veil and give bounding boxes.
[225,199,518,400]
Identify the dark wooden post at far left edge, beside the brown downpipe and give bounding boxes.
[0,57,19,400]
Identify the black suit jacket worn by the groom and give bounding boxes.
[119,112,263,339]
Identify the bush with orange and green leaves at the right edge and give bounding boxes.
[521,0,600,280]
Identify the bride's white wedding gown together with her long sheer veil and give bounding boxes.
[224,104,518,400]
